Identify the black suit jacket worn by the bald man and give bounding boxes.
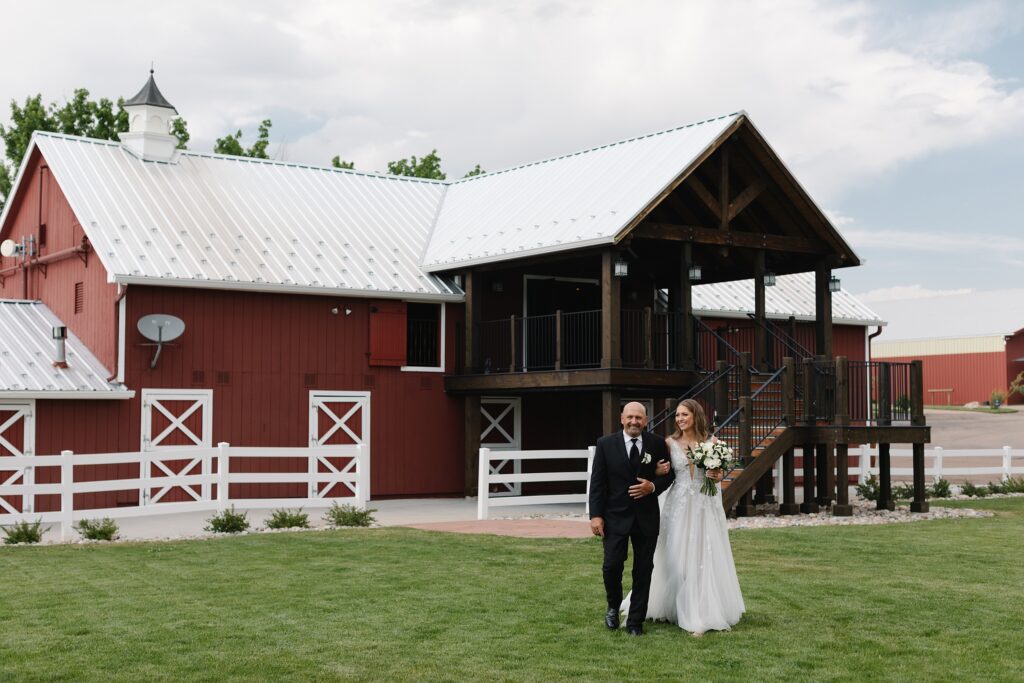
[590,431,674,536]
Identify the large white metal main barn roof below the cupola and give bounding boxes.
[29,133,462,300]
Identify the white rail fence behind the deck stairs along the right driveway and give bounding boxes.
[775,445,1024,500]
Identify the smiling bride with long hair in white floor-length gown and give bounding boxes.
[623,398,745,636]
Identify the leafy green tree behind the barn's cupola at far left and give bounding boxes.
[0,88,189,209]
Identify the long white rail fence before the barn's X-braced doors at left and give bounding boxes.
[0,442,370,540]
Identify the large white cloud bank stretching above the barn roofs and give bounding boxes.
[0,0,1024,193]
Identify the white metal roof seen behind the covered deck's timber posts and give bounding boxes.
[693,272,886,325]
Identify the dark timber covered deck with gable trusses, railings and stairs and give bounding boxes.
[444,115,930,515]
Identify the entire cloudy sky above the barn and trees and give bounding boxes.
[0,0,1024,338]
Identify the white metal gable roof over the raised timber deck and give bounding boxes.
[422,113,742,271]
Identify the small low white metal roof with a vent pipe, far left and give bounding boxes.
[0,299,135,398]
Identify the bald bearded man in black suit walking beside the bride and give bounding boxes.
[590,402,673,636]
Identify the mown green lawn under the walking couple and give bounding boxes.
[0,499,1024,681]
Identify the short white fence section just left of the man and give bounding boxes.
[476,446,595,519]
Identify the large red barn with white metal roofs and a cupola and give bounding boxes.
[0,77,897,516]
